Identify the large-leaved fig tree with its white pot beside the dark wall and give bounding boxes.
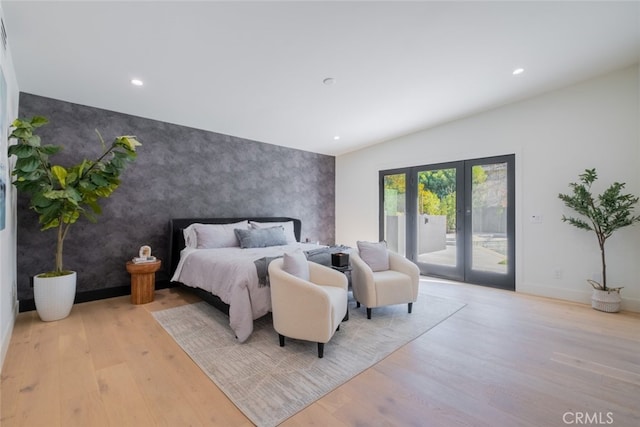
[8,116,141,321]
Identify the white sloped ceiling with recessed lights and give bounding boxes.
[1,0,640,155]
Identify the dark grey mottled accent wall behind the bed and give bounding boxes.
[17,93,335,300]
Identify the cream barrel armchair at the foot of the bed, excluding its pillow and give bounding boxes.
[269,258,348,358]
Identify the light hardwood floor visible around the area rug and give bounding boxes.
[0,281,640,427]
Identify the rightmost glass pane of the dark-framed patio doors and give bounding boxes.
[471,163,508,274]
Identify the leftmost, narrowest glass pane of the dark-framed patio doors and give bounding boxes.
[384,173,407,256]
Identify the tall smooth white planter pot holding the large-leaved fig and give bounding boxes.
[33,271,76,322]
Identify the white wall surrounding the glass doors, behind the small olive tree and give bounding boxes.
[336,65,640,311]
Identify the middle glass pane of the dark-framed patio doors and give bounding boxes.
[416,168,457,267]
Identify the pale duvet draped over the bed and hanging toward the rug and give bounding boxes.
[171,243,319,342]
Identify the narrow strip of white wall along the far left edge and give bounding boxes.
[0,4,19,371]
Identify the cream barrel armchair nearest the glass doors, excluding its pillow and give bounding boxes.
[351,249,420,319]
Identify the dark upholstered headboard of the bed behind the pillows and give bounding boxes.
[169,217,302,278]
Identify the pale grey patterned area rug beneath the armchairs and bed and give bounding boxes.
[153,294,464,427]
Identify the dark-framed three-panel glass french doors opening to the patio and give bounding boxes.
[380,155,515,290]
